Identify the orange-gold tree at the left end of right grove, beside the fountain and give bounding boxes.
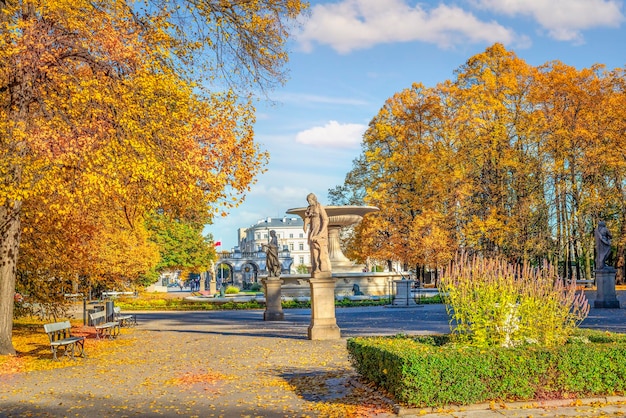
[331,84,452,268]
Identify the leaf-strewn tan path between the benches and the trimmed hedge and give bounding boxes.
[0,312,391,417]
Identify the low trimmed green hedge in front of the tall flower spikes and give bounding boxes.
[348,330,626,407]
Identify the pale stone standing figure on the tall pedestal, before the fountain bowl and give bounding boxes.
[304,193,331,273]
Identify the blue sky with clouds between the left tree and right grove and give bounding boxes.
[205,0,626,250]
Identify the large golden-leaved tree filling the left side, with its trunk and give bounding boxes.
[0,0,306,354]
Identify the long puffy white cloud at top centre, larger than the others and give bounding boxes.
[297,0,527,53]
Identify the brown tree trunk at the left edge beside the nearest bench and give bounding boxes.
[0,202,22,355]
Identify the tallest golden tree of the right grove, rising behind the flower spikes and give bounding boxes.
[448,44,547,261]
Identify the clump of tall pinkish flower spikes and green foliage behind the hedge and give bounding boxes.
[440,256,589,347]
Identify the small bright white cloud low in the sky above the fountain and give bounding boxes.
[296,120,367,148]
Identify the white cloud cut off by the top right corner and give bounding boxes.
[473,0,624,42]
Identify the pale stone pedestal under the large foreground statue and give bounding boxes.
[307,272,341,340]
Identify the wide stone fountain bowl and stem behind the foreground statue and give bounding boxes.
[287,206,379,272]
